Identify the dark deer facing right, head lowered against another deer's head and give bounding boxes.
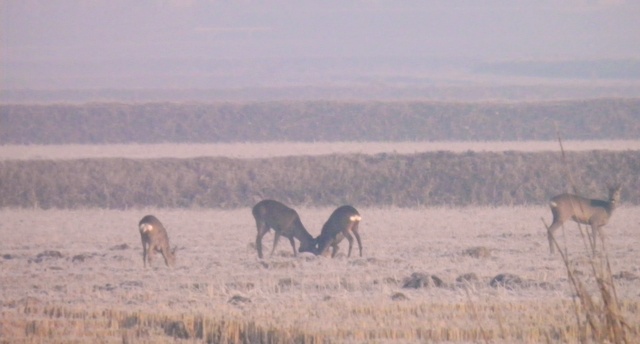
[252,199,316,258]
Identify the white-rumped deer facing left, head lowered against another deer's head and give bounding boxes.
[316,205,362,258]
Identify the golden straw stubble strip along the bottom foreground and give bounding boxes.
[0,293,640,344]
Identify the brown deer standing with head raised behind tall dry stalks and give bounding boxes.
[547,185,621,254]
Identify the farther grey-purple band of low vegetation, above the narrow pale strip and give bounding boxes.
[0,98,640,144]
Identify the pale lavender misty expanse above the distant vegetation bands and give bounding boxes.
[0,0,640,97]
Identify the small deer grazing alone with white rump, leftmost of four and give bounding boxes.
[138,215,176,268]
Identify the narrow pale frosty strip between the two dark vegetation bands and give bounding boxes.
[0,140,640,161]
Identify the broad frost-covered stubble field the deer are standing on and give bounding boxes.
[0,206,640,343]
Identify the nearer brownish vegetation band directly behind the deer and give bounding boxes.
[0,151,640,209]
